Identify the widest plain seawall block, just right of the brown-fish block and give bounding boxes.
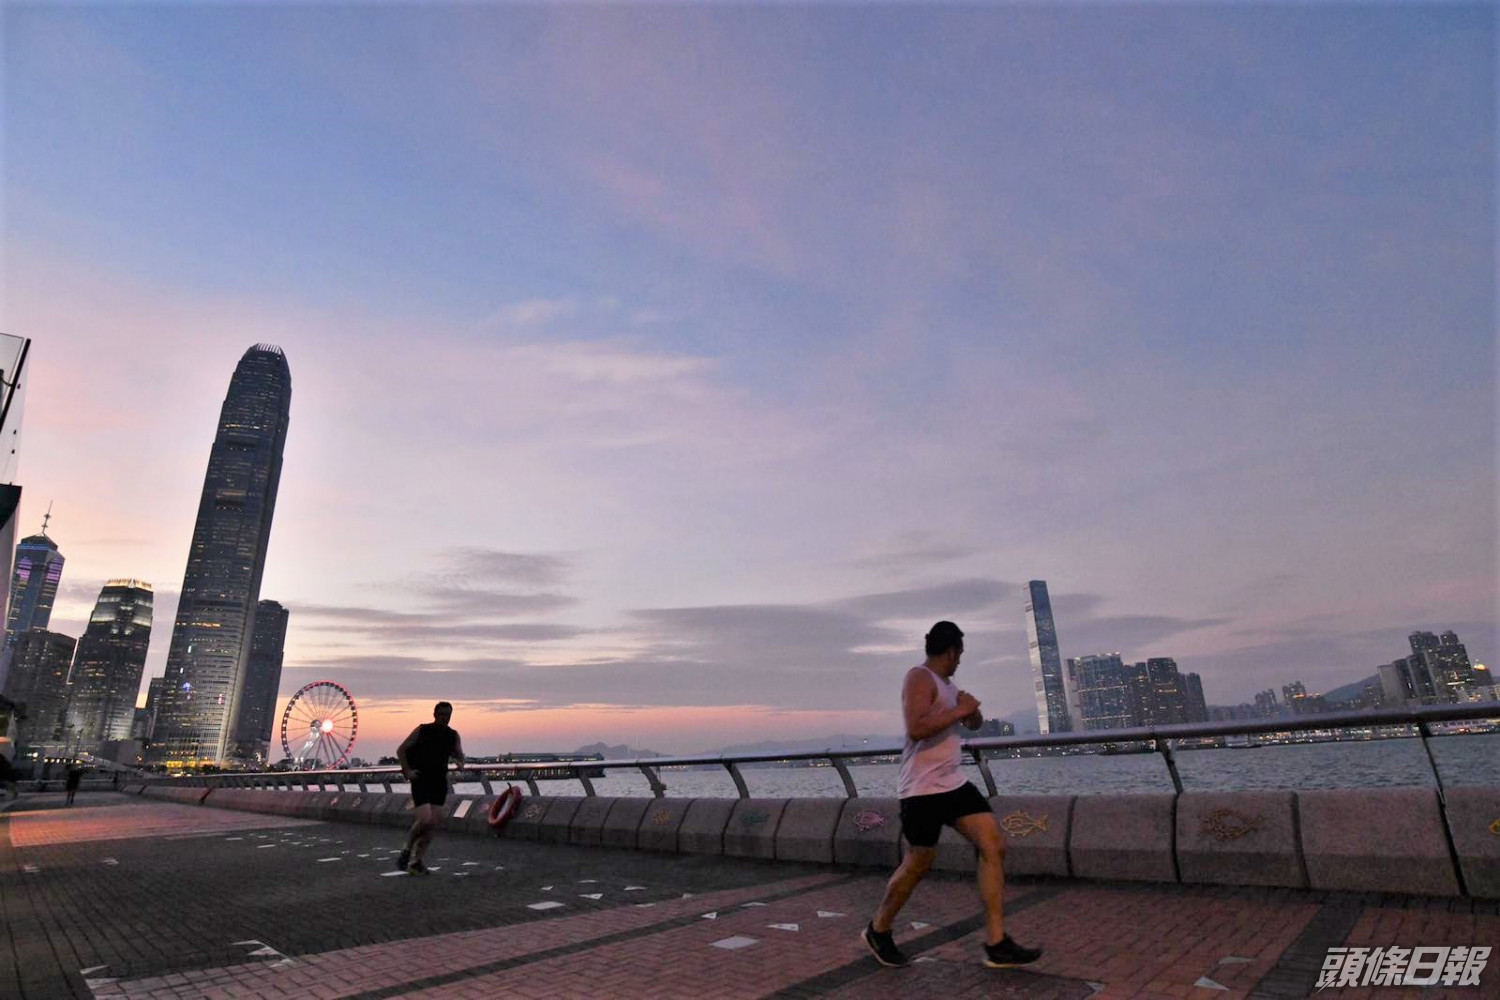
[1298,789,1458,895]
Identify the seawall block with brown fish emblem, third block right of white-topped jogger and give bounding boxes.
[1178,792,1307,889]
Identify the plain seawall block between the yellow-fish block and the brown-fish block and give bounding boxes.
[1068,795,1178,882]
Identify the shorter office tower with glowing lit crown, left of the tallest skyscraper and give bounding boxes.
[68,580,152,753]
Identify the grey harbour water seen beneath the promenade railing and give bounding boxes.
[444,733,1500,798]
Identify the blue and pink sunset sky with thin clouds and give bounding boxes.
[0,3,1500,759]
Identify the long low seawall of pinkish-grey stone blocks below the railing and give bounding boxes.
[164,781,1500,898]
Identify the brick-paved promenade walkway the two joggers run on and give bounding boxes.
[0,793,1500,1000]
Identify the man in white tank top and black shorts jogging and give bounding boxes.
[863,622,1041,969]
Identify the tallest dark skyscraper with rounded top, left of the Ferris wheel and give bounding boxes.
[152,345,291,768]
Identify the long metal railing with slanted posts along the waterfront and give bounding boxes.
[162,702,1500,799]
